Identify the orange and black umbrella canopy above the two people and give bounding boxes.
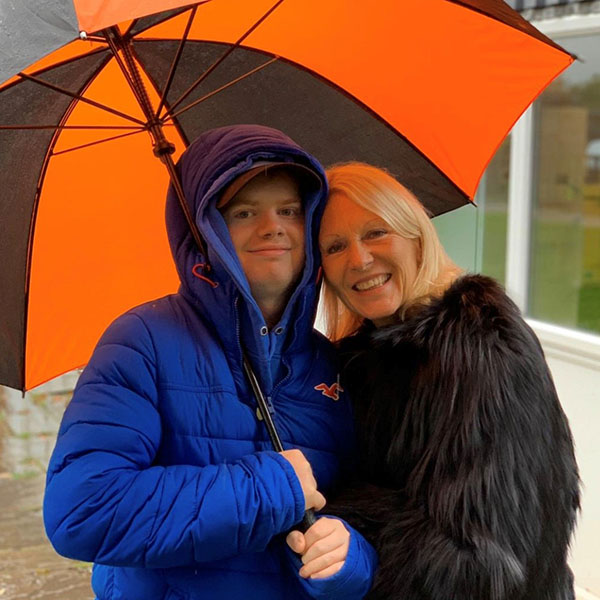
[0,0,573,389]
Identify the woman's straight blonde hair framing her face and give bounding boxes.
[322,162,461,340]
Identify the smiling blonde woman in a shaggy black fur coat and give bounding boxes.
[319,163,579,600]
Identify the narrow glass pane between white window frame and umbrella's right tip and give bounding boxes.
[476,136,510,284]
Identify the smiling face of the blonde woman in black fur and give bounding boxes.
[319,193,418,326]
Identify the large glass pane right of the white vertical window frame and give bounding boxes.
[528,35,600,332]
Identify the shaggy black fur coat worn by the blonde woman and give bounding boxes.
[327,275,579,600]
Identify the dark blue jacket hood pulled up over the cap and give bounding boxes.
[166,125,327,388]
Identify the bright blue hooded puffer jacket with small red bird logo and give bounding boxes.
[44,126,376,600]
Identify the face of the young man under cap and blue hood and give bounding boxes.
[222,170,304,308]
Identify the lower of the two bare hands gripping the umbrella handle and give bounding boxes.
[286,517,350,579]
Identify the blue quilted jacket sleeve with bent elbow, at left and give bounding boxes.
[44,313,304,568]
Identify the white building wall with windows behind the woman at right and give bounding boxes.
[435,0,600,599]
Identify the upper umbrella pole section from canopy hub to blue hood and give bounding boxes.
[102,27,208,258]
